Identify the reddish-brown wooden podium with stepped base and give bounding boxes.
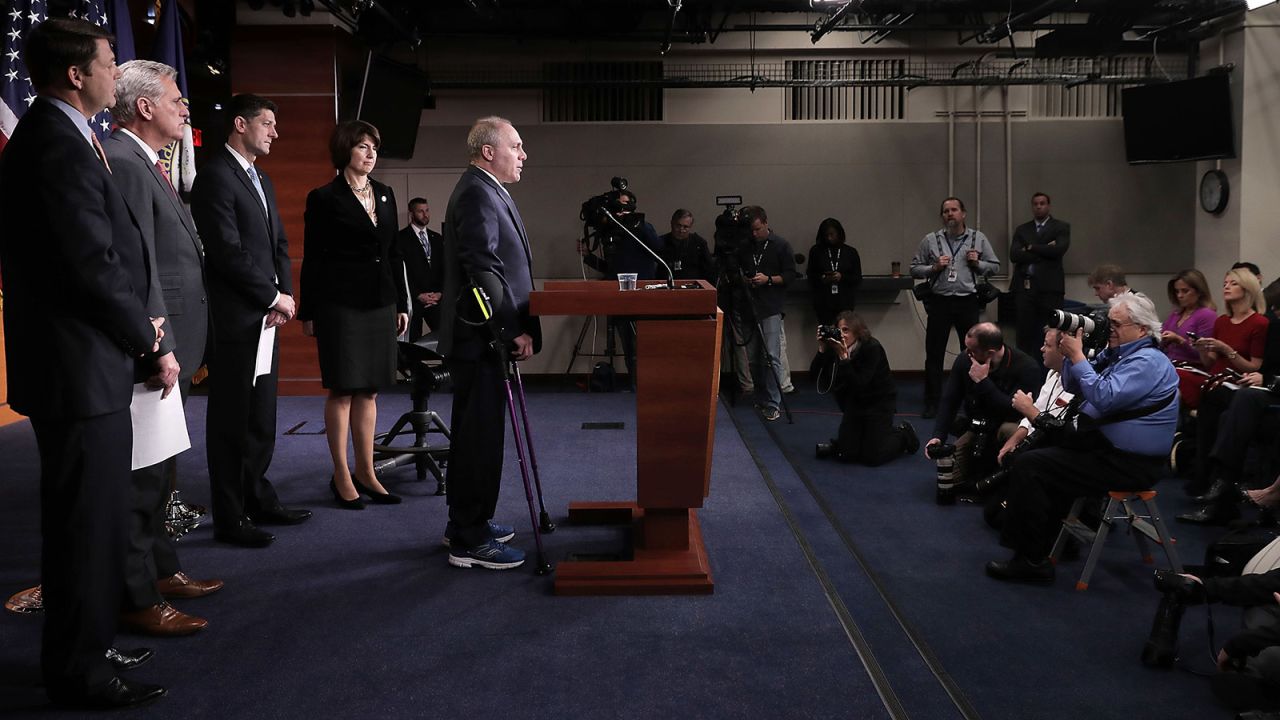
[530,281,722,594]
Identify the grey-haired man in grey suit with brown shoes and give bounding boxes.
[102,60,223,635]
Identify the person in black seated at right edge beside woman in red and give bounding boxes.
[1179,275,1280,524]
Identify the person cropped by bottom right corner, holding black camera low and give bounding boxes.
[1143,569,1280,717]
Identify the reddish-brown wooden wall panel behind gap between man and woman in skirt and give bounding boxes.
[232,26,337,395]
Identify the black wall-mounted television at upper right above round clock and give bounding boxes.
[1120,73,1235,164]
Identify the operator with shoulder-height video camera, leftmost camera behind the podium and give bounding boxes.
[577,177,667,391]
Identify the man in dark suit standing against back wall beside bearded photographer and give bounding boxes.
[1009,192,1071,357]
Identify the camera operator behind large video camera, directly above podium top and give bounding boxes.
[577,178,663,392]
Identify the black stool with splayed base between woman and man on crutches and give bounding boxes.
[374,336,449,496]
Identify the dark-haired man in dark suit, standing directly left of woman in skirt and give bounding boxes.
[191,94,311,547]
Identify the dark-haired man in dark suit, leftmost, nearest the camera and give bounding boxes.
[0,18,165,708]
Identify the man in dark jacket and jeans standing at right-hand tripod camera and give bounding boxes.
[737,205,796,421]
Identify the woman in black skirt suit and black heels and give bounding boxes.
[298,120,408,510]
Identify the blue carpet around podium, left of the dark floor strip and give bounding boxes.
[0,392,890,719]
